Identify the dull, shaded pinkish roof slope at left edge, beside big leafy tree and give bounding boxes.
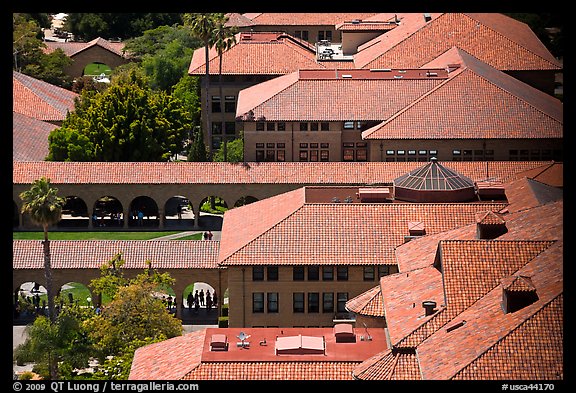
[12,112,58,161]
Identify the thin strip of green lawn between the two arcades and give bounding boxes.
[12,231,202,240]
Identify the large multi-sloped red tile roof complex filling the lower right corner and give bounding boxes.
[354,194,563,379]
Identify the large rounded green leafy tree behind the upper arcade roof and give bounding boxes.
[47,70,191,162]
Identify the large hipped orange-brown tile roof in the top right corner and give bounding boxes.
[354,13,561,71]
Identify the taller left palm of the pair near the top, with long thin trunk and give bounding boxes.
[182,13,224,160]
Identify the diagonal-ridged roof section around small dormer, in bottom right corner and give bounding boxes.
[418,241,563,379]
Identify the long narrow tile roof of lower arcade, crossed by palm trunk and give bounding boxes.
[12,240,219,269]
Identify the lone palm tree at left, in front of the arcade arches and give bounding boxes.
[20,177,66,323]
